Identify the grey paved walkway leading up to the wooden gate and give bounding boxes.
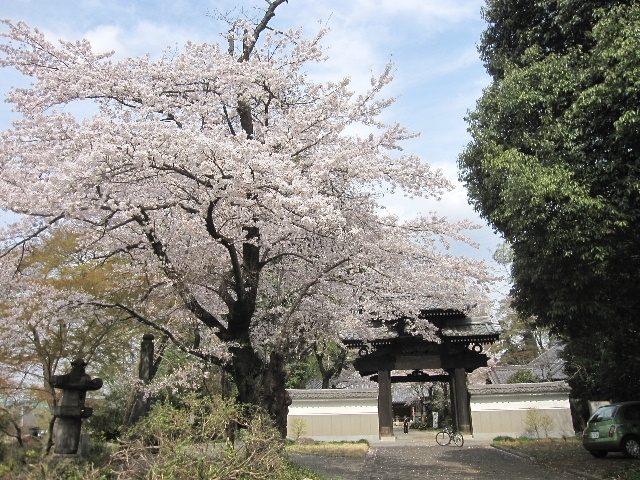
[293,427,596,480]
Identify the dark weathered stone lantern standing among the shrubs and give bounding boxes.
[50,358,102,455]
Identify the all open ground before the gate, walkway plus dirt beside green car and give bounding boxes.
[291,431,634,480]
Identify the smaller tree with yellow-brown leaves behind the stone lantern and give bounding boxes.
[0,229,143,407]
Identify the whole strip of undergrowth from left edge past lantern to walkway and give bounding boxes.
[0,395,322,480]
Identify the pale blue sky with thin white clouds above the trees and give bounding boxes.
[0,0,510,296]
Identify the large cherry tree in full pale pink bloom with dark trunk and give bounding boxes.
[0,0,488,432]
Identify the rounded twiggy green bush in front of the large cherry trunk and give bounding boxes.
[114,395,295,480]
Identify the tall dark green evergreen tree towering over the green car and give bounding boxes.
[459,0,640,399]
